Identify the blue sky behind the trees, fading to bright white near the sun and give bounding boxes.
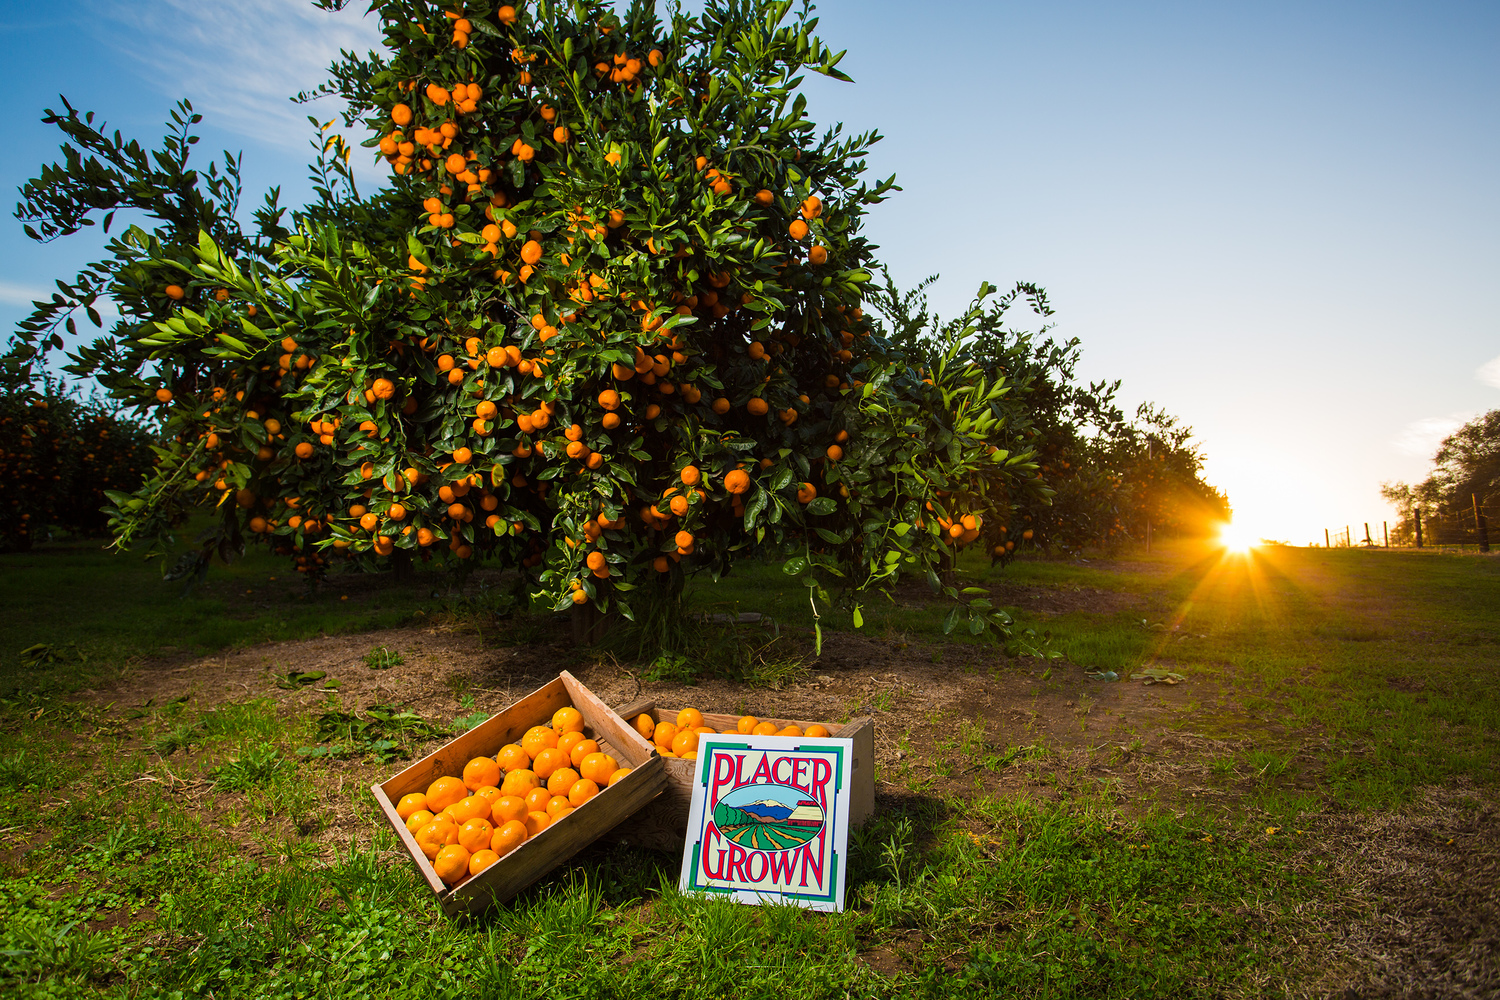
[0,0,1500,543]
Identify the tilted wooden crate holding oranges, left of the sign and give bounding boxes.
[371,670,666,916]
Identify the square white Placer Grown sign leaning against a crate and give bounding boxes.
[678,735,854,912]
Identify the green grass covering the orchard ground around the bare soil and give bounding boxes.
[0,547,1500,1000]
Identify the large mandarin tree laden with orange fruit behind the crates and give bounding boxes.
[12,0,1035,641]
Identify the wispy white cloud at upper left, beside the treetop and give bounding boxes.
[86,0,381,150]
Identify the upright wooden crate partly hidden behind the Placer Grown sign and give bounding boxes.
[611,700,875,852]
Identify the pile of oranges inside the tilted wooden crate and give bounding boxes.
[396,706,630,886]
